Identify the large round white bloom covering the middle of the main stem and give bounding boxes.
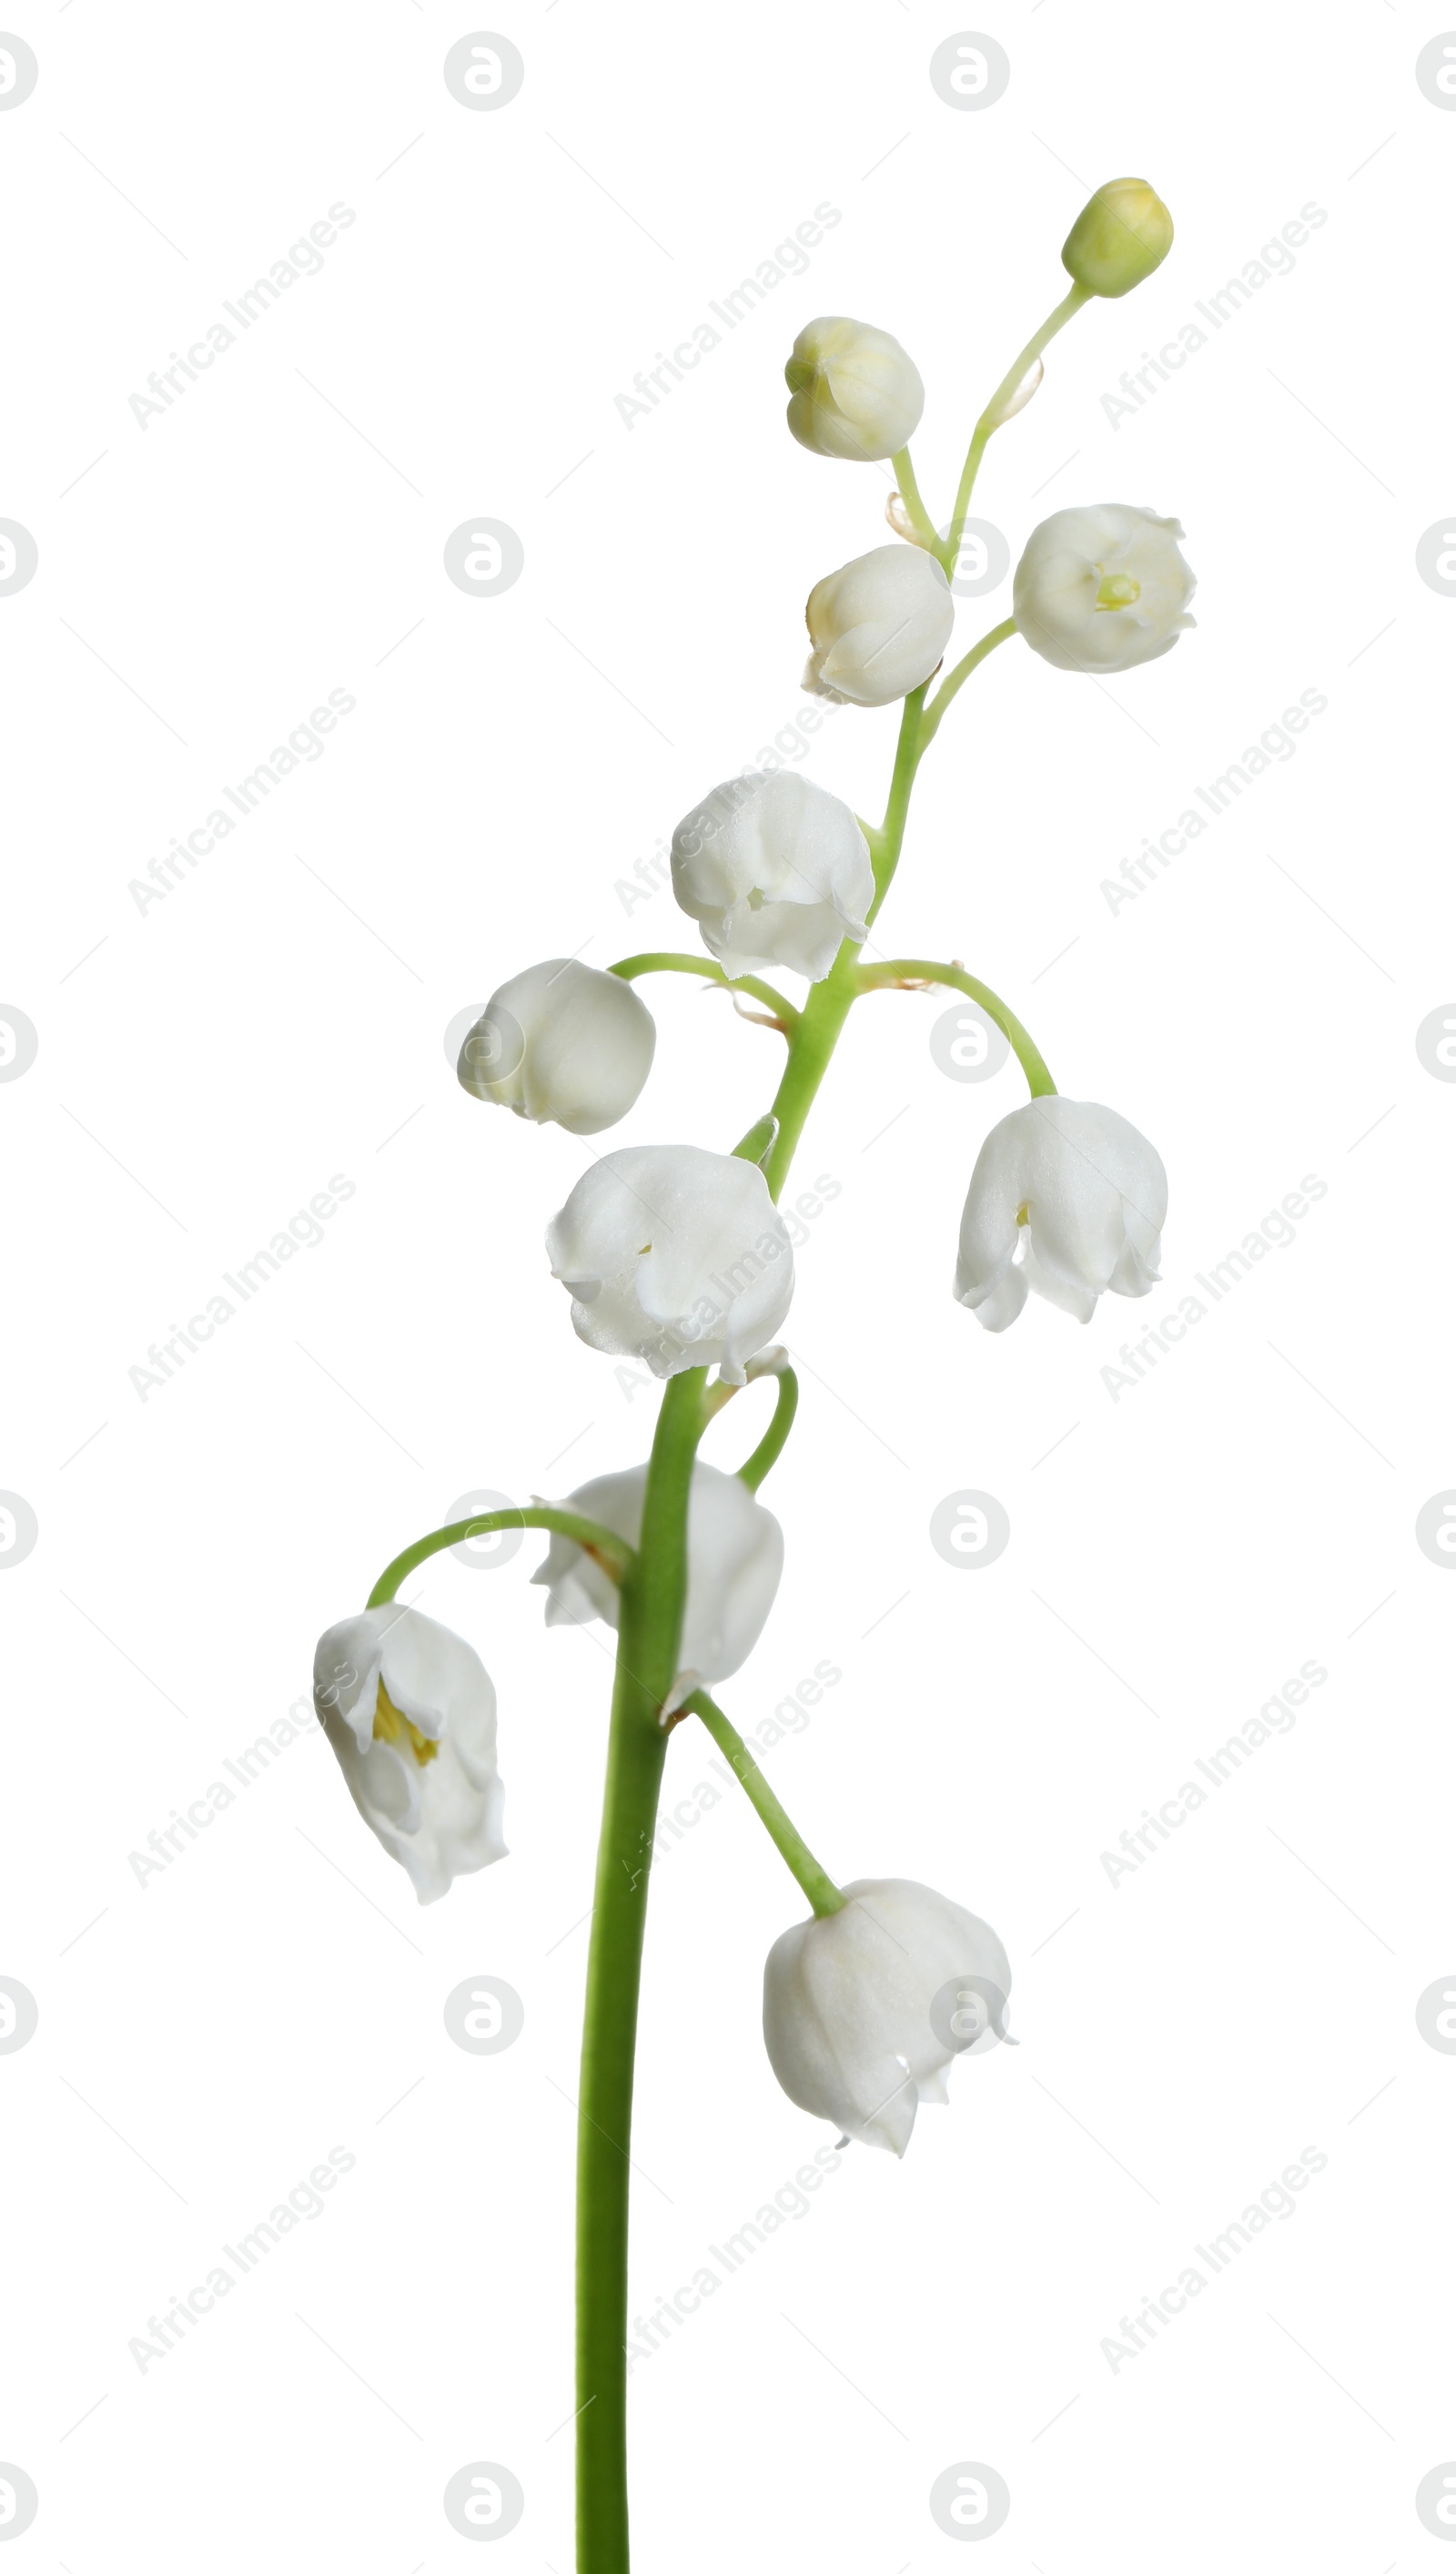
[545,1143,794,1384]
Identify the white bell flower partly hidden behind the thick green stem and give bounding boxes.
[532,1459,784,1697]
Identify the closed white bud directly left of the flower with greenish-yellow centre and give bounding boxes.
[803,546,955,705]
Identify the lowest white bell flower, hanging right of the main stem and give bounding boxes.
[764,1877,1011,2154]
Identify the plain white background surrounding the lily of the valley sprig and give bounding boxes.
[0,0,1456,2574]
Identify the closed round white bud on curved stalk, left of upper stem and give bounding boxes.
[458,958,656,1135]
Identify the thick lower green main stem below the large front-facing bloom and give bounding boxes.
[576,1367,707,2574]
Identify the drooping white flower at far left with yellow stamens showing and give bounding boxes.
[314,1601,507,1905]
